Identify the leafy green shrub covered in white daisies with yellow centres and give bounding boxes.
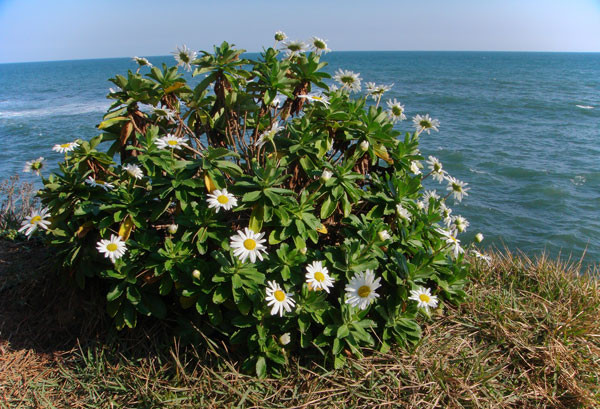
[23,32,478,375]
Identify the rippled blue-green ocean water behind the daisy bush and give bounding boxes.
[0,52,600,264]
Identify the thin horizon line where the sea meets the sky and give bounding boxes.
[0,50,600,65]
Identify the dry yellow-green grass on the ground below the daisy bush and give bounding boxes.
[0,237,600,408]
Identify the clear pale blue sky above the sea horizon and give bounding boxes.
[0,0,600,63]
